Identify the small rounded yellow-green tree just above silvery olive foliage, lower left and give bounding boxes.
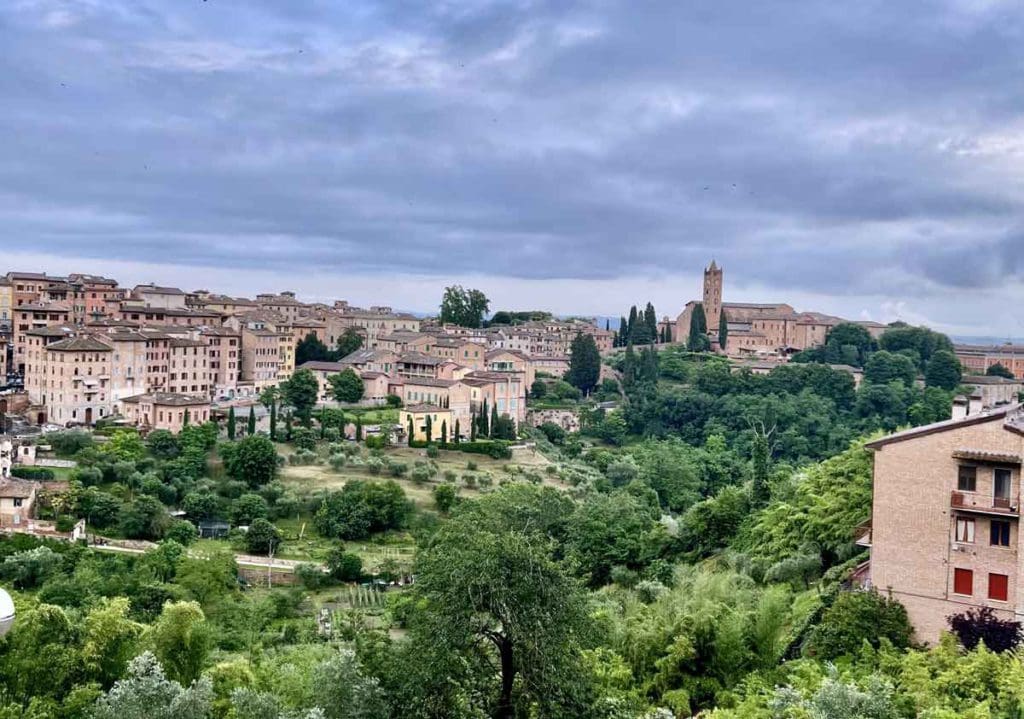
[150,601,212,685]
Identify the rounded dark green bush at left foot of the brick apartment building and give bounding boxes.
[806,590,913,660]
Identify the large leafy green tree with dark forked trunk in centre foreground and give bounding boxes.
[410,490,588,719]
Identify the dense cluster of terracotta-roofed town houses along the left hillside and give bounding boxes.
[0,271,612,431]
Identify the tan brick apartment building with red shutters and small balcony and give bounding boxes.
[861,403,1024,642]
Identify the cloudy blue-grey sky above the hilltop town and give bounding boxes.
[0,0,1024,337]
